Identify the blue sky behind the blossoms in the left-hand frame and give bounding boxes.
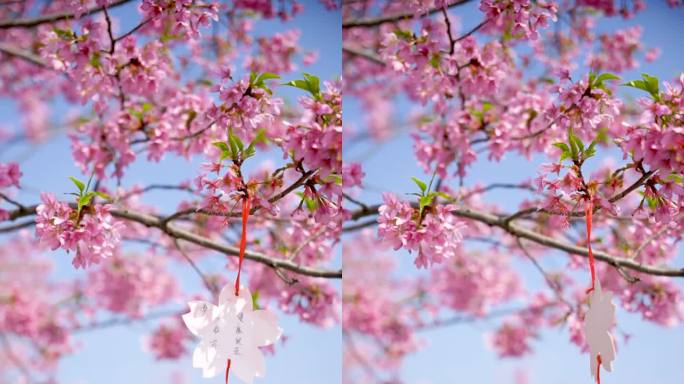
[0,0,342,384]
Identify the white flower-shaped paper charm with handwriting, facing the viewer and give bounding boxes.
[183,285,282,384]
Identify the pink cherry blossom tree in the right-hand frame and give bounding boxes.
[342,0,684,384]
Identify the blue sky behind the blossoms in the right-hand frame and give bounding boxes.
[344,0,684,384]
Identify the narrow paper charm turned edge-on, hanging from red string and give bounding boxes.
[584,279,615,379]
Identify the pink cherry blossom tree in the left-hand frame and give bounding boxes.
[0,0,343,383]
